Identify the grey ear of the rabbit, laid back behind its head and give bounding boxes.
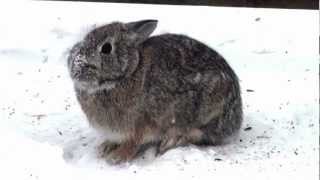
[126,20,158,39]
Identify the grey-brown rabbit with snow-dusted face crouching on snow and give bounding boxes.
[67,19,243,164]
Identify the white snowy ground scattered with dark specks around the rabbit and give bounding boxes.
[0,2,319,180]
